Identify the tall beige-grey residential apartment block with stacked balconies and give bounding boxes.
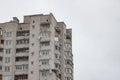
[0,13,73,80]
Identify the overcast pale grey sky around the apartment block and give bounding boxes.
[0,0,120,80]
